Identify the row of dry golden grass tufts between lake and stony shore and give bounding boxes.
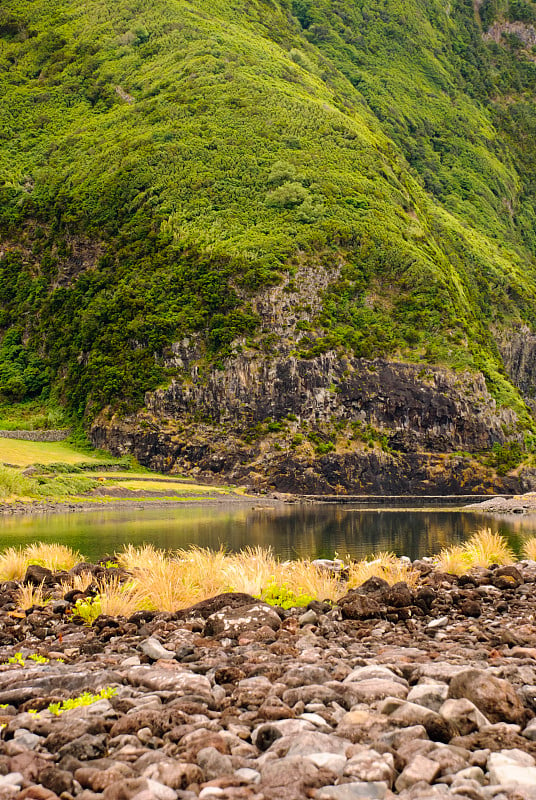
[4,529,520,616]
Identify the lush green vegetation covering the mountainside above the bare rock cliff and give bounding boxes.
[0,0,536,424]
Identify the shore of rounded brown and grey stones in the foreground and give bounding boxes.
[0,560,536,800]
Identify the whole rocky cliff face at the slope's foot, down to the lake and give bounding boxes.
[91,353,526,494]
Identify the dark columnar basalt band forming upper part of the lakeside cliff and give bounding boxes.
[145,353,514,452]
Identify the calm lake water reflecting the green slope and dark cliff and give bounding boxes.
[0,501,536,560]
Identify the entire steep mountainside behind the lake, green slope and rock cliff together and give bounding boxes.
[0,0,536,491]
